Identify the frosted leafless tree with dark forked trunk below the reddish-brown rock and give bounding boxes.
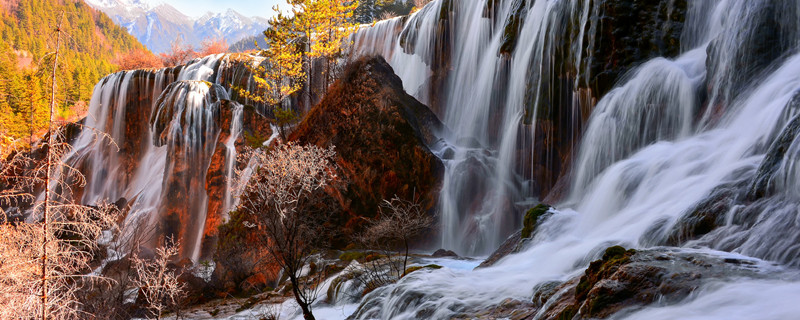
[239,143,337,320]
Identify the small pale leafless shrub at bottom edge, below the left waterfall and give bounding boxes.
[131,238,186,319]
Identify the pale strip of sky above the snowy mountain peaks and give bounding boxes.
[153,0,286,18]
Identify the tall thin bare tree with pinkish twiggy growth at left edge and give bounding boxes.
[0,14,117,319]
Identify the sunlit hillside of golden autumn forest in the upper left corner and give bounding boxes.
[0,0,145,153]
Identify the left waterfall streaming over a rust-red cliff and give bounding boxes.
[61,55,266,262]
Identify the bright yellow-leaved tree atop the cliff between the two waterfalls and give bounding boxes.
[238,0,358,140]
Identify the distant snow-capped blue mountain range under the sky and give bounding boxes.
[84,0,267,53]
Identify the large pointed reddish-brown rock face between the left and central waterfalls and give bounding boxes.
[289,57,446,242]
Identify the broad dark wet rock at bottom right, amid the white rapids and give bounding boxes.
[540,246,767,319]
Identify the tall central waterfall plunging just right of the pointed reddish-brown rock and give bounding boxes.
[354,0,604,254]
